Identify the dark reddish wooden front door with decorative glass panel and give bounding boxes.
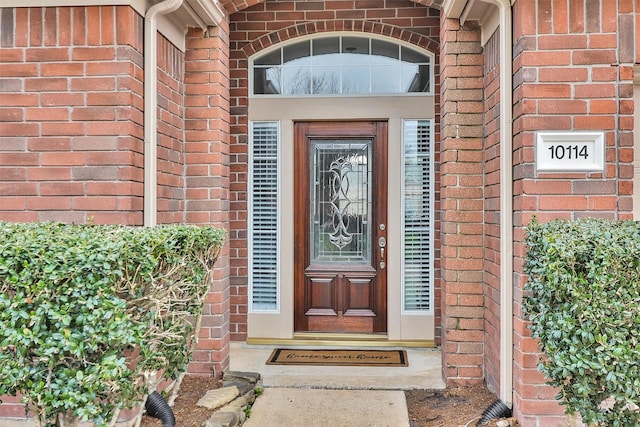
[294,122,387,333]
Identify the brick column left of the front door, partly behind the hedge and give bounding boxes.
[185,22,230,374]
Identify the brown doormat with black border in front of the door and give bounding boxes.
[267,348,409,366]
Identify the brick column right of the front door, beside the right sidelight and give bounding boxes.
[440,16,484,386]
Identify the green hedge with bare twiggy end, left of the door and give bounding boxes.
[0,222,225,425]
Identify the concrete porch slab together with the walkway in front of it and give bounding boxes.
[230,342,445,427]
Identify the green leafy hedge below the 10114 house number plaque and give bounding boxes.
[524,219,640,426]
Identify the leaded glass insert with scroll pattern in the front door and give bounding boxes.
[310,140,372,263]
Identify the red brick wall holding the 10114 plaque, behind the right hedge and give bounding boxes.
[513,0,635,426]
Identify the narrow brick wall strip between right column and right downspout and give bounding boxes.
[482,31,508,393]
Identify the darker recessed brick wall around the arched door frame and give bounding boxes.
[223,0,439,340]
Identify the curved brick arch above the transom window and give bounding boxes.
[240,19,438,58]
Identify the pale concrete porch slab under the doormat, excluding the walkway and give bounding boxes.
[230,342,445,390]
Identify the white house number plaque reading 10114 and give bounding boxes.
[536,132,604,172]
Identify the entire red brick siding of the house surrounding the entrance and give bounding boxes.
[0,0,640,427]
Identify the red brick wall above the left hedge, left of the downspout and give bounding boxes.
[0,6,143,224]
